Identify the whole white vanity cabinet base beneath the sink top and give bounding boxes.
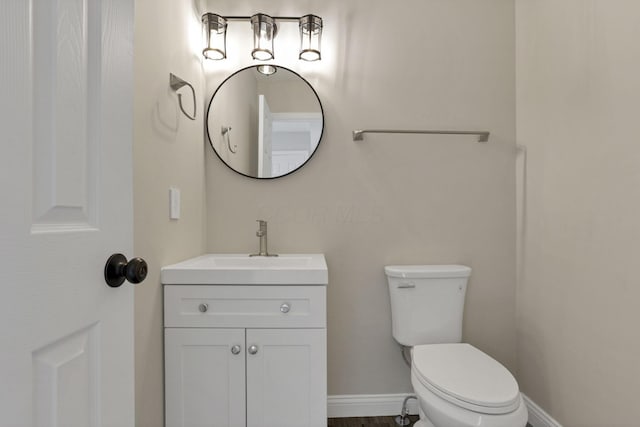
[164,284,327,427]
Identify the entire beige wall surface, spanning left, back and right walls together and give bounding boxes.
[134,0,640,427]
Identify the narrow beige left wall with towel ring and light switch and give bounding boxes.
[134,0,205,427]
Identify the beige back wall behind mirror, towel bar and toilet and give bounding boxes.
[205,0,516,395]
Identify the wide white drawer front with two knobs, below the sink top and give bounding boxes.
[164,285,327,328]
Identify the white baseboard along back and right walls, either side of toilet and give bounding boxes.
[327,394,562,427]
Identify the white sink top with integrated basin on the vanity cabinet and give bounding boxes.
[161,254,328,285]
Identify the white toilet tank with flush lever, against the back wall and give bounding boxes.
[384,265,471,347]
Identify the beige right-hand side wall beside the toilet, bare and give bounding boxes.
[516,0,640,427]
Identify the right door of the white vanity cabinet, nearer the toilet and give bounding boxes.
[247,329,327,427]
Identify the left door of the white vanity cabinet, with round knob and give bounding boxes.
[164,328,246,427]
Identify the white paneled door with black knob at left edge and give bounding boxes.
[0,0,134,427]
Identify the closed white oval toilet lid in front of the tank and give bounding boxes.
[412,343,520,414]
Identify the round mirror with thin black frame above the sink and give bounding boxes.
[207,65,324,178]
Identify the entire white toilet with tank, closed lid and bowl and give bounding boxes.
[384,265,527,427]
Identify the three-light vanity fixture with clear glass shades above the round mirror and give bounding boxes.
[202,13,322,63]
